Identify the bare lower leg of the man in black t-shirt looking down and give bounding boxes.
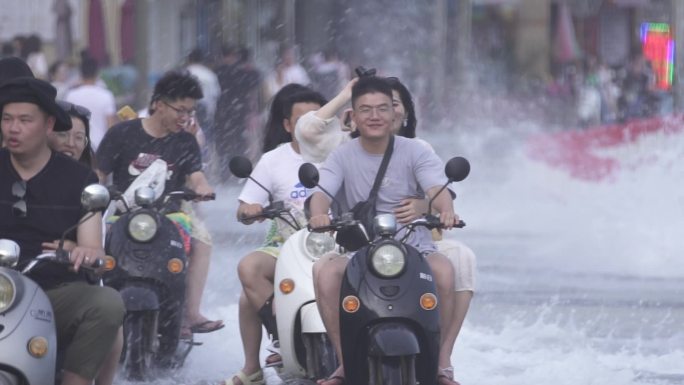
[185,239,211,325]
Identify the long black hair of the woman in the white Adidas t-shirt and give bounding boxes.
[262,83,327,152]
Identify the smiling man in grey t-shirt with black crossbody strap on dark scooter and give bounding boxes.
[309,77,458,385]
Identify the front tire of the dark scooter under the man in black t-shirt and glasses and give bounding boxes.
[123,311,156,381]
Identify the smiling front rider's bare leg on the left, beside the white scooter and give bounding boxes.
[313,254,349,384]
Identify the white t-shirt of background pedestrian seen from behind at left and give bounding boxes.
[66,84,116,151]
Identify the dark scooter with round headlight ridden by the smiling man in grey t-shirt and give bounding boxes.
[299,157,470,385]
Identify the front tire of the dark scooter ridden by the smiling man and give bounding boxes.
[368,355,416,385]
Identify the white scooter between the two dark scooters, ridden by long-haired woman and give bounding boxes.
[230,157,338,379]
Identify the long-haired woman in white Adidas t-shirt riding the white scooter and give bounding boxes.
[224,84,326,385]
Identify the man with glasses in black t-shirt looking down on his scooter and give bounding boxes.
[96,71,223,337]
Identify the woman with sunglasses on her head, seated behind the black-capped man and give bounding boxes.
[43,100,123,385]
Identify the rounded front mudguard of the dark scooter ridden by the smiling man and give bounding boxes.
[368,322,420,357]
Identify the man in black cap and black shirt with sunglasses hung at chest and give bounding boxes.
[0,76,124,385]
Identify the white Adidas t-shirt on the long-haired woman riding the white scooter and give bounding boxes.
[238,143,319,239]
